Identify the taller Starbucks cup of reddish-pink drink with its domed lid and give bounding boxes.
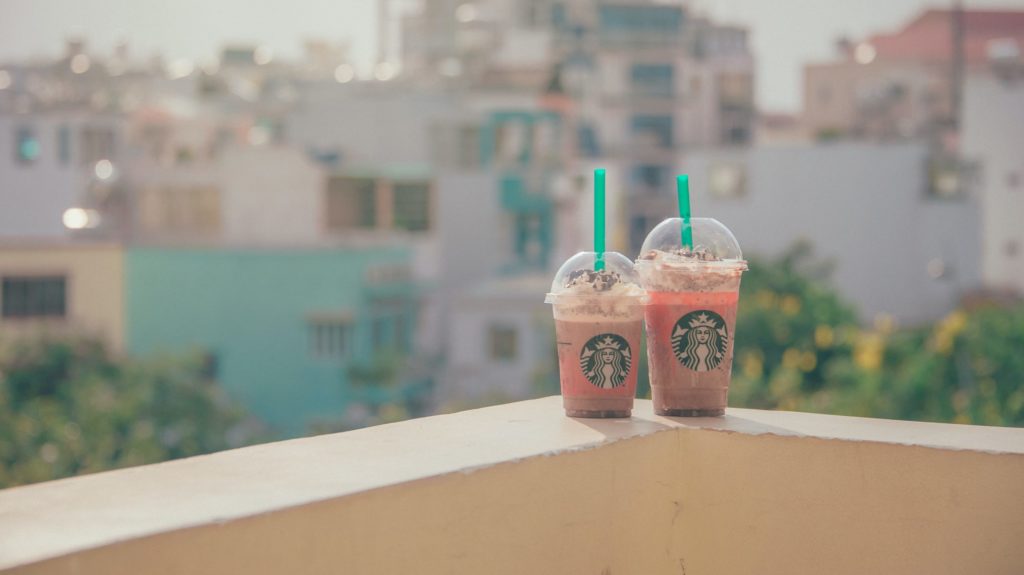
[636,218,746,416]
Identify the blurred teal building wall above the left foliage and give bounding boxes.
[125,248,418,436]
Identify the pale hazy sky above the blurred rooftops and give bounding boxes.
[6,0,1024,110]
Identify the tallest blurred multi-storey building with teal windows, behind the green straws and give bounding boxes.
[402,0,755,251]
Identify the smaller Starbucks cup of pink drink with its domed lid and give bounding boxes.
[544,252,645,417]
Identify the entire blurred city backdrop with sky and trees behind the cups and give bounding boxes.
[0,0,1024,487]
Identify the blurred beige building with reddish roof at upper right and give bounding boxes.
[803,9,1024,139]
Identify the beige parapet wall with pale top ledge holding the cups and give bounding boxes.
[0,397,1024,575]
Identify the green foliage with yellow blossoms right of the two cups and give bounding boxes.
[729,245,1024,426]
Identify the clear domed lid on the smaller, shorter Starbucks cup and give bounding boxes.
[544,252,645,304]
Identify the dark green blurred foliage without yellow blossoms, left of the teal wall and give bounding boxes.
[0,339,261,487]
